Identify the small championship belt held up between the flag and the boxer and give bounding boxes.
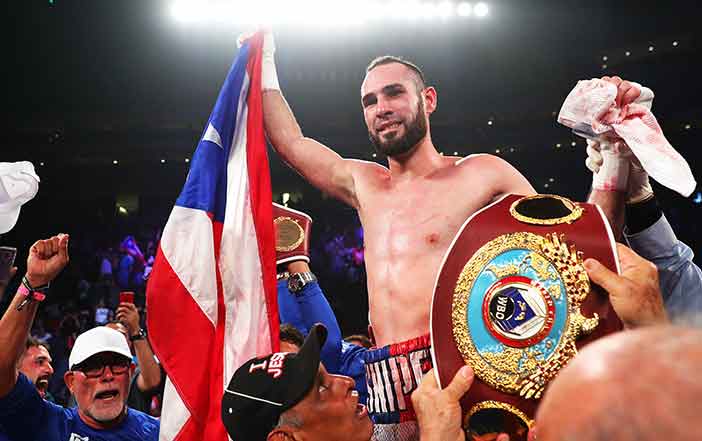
[273,202,312,265]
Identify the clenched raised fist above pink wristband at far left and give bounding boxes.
[27,234,69,288]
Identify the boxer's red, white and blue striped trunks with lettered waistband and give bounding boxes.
[363,335,432,441]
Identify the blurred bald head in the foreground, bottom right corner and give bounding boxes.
[536,326,702,441]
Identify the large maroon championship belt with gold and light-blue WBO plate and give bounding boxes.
[431,195,622,441]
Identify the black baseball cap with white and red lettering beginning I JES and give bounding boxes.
[222,324,327,441]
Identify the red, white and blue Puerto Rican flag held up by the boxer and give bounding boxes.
[146,33,279,441]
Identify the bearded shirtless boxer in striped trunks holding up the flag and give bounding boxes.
[262,34,628,439]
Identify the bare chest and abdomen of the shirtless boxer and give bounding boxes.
[359,163,504,344]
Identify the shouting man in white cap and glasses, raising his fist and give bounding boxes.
[0,234,159,441]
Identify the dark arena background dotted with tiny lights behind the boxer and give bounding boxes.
[0,0,702,340]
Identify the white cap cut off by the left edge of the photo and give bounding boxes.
[0,161,39,234]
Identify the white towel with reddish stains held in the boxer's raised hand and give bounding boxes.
[558,79,697,196]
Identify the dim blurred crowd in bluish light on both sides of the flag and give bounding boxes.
[0,204,367,414]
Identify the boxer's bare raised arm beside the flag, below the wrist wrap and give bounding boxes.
[263,89,358,208]
